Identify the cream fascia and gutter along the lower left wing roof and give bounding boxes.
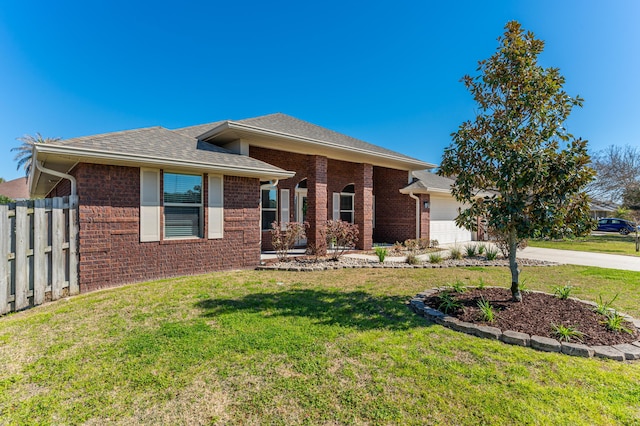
[34,144,295,180]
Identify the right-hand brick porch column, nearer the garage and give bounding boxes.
[354,164,373,250]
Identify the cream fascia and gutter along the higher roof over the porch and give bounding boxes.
[198,121,436,170]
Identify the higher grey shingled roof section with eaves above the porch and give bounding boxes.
[175,113,435,170]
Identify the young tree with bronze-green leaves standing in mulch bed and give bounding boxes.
[439,21,593,301]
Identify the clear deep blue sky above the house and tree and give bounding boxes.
[0,0,640,180]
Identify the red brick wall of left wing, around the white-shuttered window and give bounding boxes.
[65,163,260,291]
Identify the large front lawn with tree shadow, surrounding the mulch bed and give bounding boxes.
[0,266,640,425]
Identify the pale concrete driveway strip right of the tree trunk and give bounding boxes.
[517,247,640,271]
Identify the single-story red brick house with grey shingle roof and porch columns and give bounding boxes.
[30,114,470,291]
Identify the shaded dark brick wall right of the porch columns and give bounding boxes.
[373,167,418,243]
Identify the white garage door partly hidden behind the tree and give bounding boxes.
[429,194,471,244]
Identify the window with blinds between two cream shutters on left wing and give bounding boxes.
[163,173,202,238]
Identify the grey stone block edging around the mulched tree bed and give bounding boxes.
[408,288,640,361]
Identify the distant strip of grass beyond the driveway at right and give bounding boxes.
[529,232,640,256]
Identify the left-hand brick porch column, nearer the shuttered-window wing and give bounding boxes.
[307,155,327,254]
